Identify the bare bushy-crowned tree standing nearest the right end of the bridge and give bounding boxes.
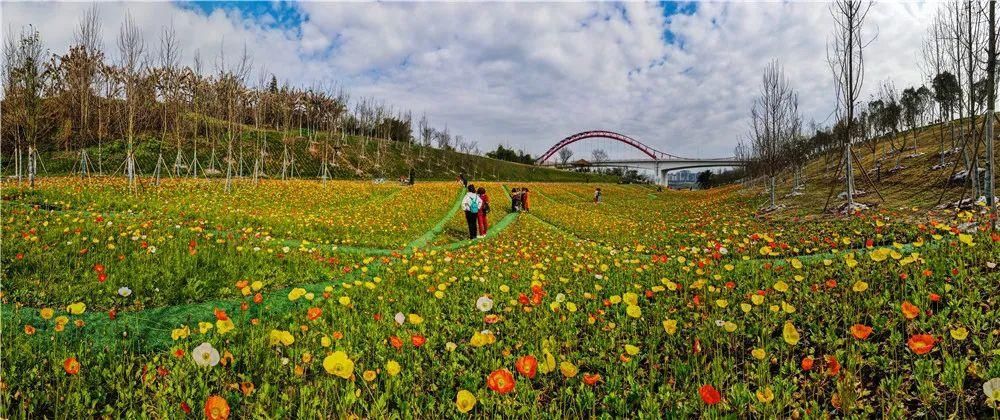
[750,60,802,209]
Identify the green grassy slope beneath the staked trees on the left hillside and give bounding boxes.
[21,112,614,182]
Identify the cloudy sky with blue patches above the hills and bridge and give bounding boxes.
[0,2,939,157]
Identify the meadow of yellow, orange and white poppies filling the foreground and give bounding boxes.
[0,178,1000,419]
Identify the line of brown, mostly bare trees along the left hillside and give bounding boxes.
[0,6,479,188]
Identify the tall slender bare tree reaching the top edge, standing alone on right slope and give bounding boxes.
[827,0,874,210]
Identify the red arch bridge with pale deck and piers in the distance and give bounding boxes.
[535,130,746,186]
